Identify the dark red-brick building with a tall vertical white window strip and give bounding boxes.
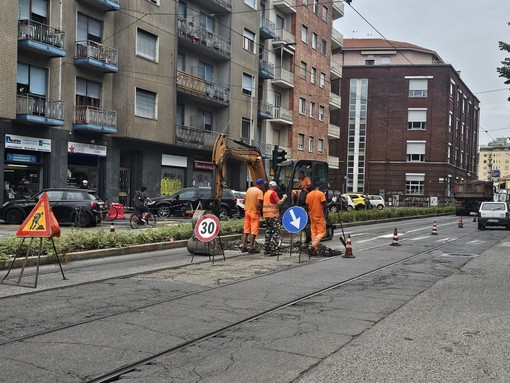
[337,39,480,203]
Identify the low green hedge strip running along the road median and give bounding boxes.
[0,207,455,260]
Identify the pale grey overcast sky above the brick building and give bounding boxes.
[334,0,510,145]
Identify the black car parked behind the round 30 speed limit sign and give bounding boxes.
[151,187,239,219]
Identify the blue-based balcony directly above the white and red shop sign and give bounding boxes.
[73,105,117,133]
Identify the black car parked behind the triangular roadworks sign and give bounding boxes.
[0,188,104,227]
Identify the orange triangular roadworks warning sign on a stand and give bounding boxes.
[16,193,60,238]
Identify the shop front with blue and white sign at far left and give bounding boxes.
[3,134,51,201]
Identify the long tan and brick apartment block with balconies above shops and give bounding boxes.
[0,0,343,205]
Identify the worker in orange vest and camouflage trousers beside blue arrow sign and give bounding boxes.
[262,181,287,255]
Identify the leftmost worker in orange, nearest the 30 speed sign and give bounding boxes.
[241,178,265,253]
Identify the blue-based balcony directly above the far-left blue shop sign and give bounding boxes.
[16,94,64,126]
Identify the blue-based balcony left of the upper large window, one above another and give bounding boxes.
[74,40,119,73]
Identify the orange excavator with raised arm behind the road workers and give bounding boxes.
[188,134,334,253]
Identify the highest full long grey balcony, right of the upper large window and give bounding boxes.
[177,17,231,60]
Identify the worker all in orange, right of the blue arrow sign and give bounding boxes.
[306,182,336,254]
